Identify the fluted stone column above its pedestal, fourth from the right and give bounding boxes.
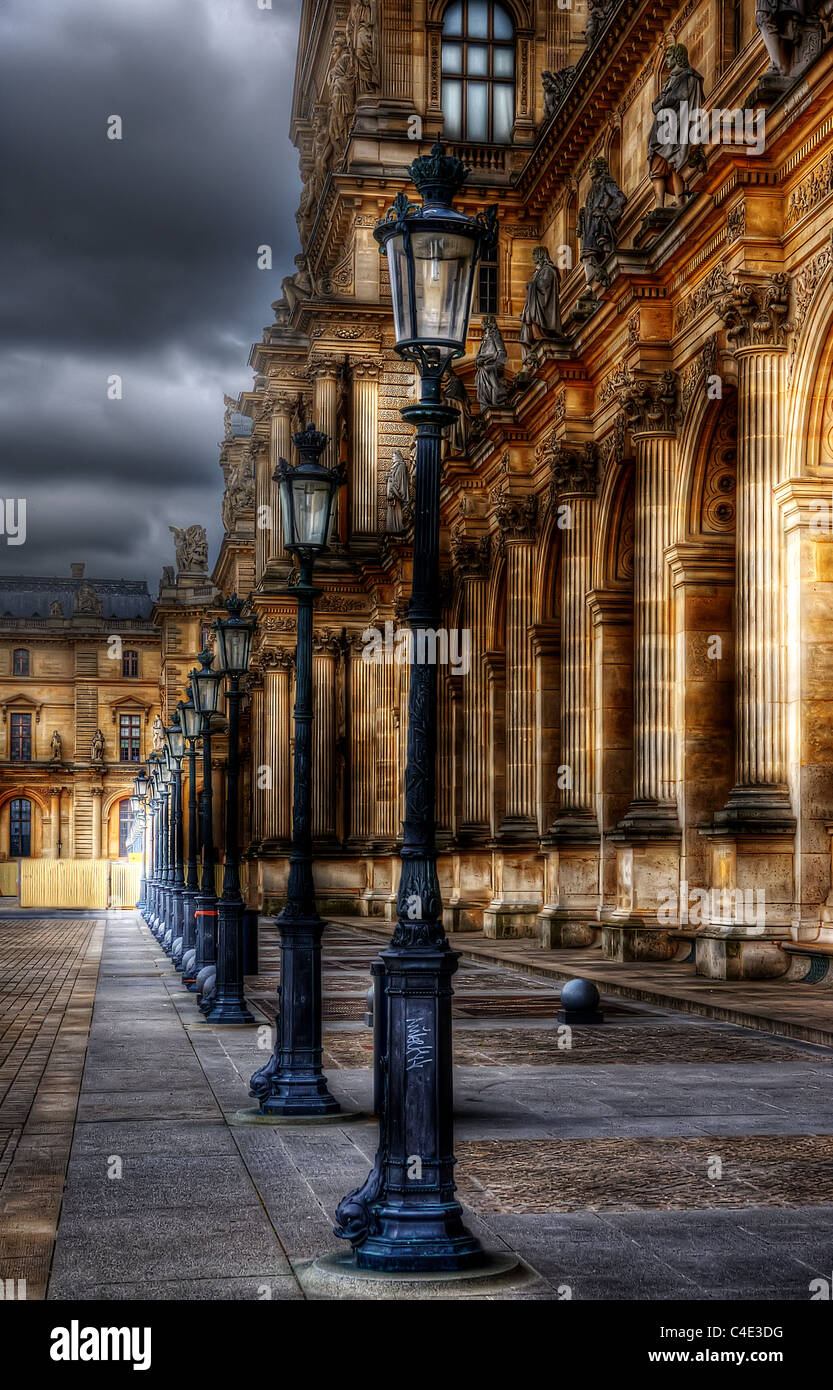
[494,493,538,840]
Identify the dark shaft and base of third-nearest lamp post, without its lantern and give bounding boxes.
[206,676,254,1023]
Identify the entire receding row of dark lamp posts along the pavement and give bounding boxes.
[136,145,495,1273]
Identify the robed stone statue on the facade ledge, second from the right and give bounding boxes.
[648,43,704,207]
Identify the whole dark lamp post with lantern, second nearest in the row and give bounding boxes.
[250,424,343,1115]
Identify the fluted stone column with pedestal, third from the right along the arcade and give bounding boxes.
[538,443,599,947]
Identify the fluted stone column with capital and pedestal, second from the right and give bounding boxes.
[602,371,681,960]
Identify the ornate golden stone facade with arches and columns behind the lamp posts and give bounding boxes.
[214,0,833,980]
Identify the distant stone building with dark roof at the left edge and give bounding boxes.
[0,564,160,859]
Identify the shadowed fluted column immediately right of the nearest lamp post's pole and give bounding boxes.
[452,525,492,841]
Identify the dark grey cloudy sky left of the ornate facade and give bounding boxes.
[0,0,300,594]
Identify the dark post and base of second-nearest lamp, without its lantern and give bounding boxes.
[252,559,341,1115]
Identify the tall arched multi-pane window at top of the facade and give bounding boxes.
[442,0,515,145]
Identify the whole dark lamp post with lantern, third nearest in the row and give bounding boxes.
[206,594,256,1023]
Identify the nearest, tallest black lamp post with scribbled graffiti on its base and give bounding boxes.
[338,145,495,1273]
